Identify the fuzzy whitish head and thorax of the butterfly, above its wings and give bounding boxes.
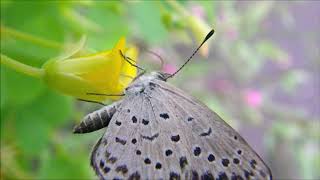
[125,71,171,95]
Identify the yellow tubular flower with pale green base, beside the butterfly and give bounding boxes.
[43,38,138,102]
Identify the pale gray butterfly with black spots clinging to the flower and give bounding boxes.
[74,30,272,180]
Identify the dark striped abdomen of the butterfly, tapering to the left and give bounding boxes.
[73,102,120,134]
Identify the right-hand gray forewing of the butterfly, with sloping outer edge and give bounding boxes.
[151,80,272,179]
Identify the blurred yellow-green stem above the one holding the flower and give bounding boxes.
[0,26,63,49]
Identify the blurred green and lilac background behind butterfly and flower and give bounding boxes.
[1,0,320,179]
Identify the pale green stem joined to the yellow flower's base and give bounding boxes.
[0,54,44,79]
